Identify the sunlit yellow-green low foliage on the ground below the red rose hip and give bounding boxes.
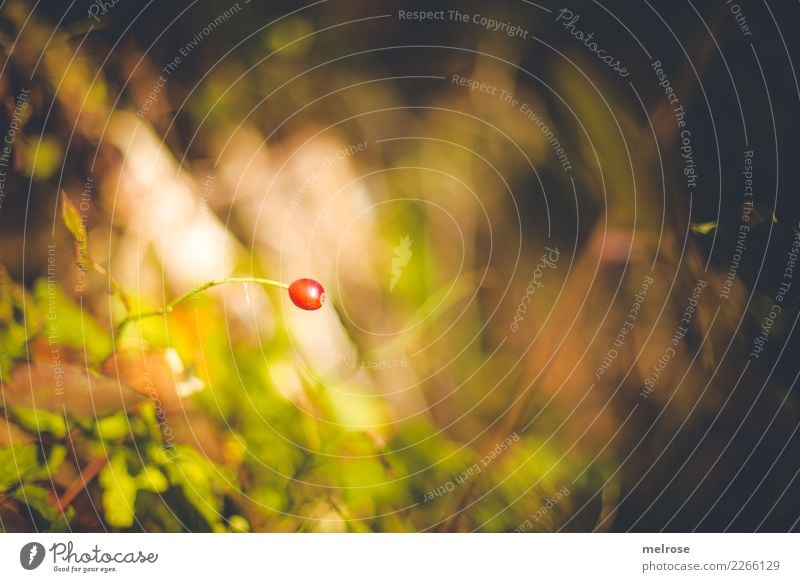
[0,252,599,531]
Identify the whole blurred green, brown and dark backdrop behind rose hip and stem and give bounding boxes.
[0,0,800,532]
